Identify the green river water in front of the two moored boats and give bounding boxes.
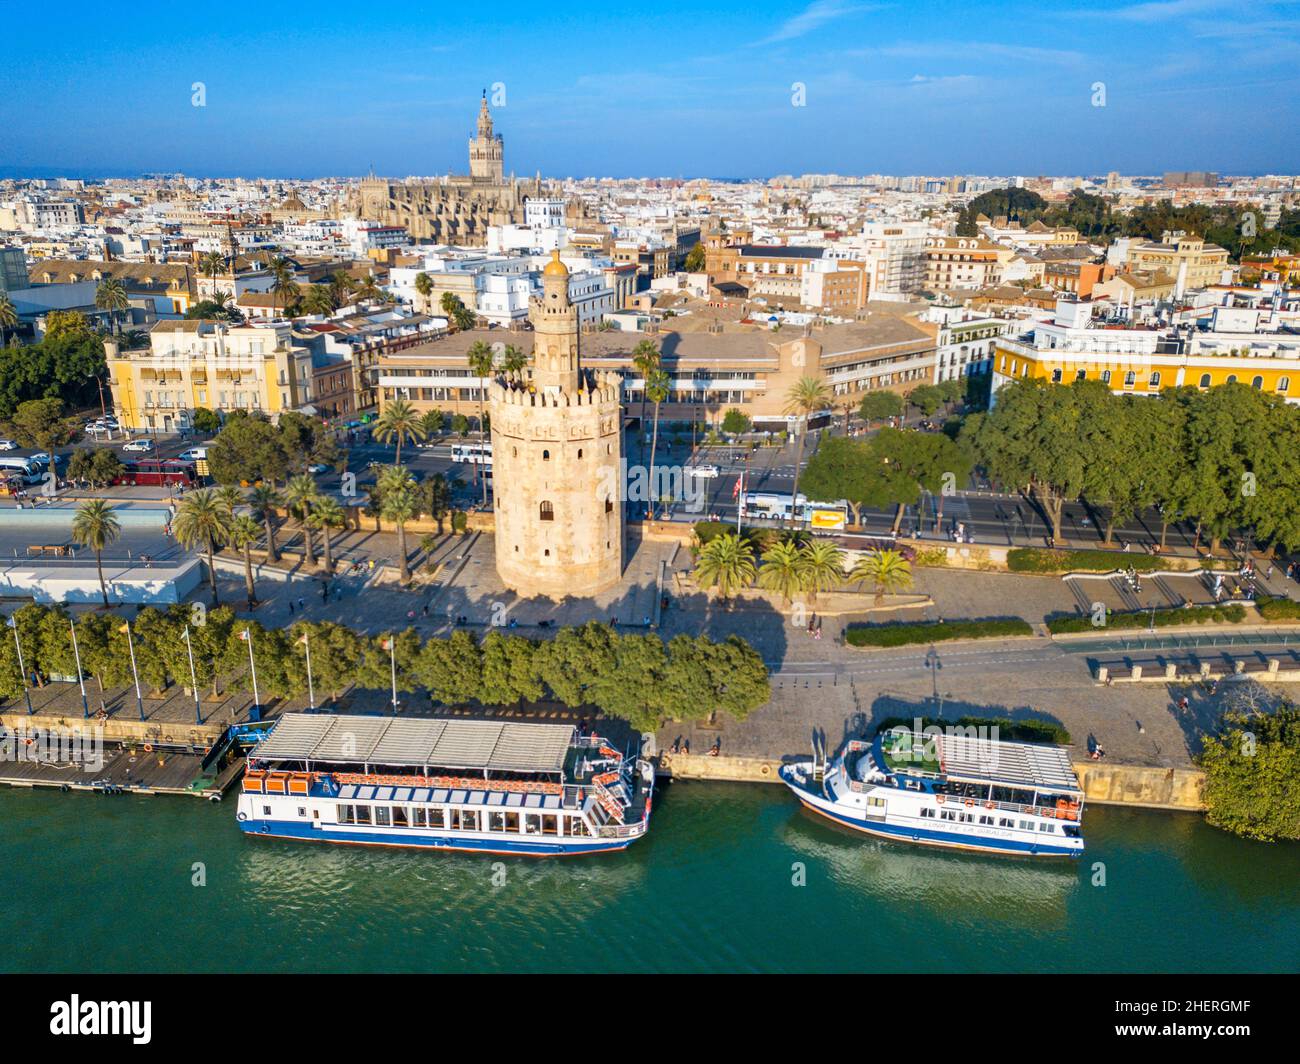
[0,783,1300,972]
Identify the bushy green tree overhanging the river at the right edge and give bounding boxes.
[1197,702,1300,842]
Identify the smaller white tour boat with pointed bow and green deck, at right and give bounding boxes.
[780,728,1083,857]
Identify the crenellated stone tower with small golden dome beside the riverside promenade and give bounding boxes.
[488,251,623,600]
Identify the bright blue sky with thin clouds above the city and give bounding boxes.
[0,0,1300,177]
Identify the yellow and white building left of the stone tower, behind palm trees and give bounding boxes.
[104,320,312,432]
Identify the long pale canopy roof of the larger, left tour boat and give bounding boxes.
[250,713,575,773]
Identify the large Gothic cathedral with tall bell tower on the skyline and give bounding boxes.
[348,92,559,245]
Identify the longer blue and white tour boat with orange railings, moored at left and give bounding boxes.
[237,713,654,857]
